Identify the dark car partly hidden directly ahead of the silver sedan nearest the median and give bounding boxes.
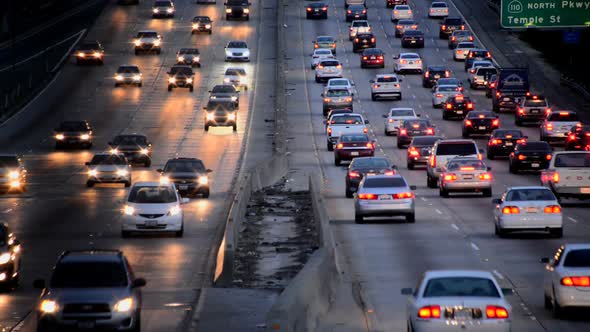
[344,157,396,198]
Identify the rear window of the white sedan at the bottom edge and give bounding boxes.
[424,277,500,298]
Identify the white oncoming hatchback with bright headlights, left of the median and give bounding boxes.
[121,182,189,237]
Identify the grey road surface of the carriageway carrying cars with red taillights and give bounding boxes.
[286,0,590,331]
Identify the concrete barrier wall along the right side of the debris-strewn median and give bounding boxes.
[266,177,340,332]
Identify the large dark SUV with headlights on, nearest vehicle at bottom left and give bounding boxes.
[34,250,146,332]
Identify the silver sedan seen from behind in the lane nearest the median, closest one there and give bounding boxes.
[354,174,416,224]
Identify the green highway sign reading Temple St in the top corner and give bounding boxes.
[500,0,590,29]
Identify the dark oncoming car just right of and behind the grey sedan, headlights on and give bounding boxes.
[109,134,152,167]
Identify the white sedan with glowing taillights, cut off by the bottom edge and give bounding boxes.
[402,270,512,332]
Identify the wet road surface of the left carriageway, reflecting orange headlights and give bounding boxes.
[0,0,275,331]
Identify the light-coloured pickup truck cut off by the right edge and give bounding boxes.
[541,151,590,199]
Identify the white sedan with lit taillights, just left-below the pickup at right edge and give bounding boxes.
[493,186,563,237]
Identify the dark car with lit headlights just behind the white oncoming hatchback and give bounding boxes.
[158,158,213,198]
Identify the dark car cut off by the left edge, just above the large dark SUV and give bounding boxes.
[0,222,21,289]
